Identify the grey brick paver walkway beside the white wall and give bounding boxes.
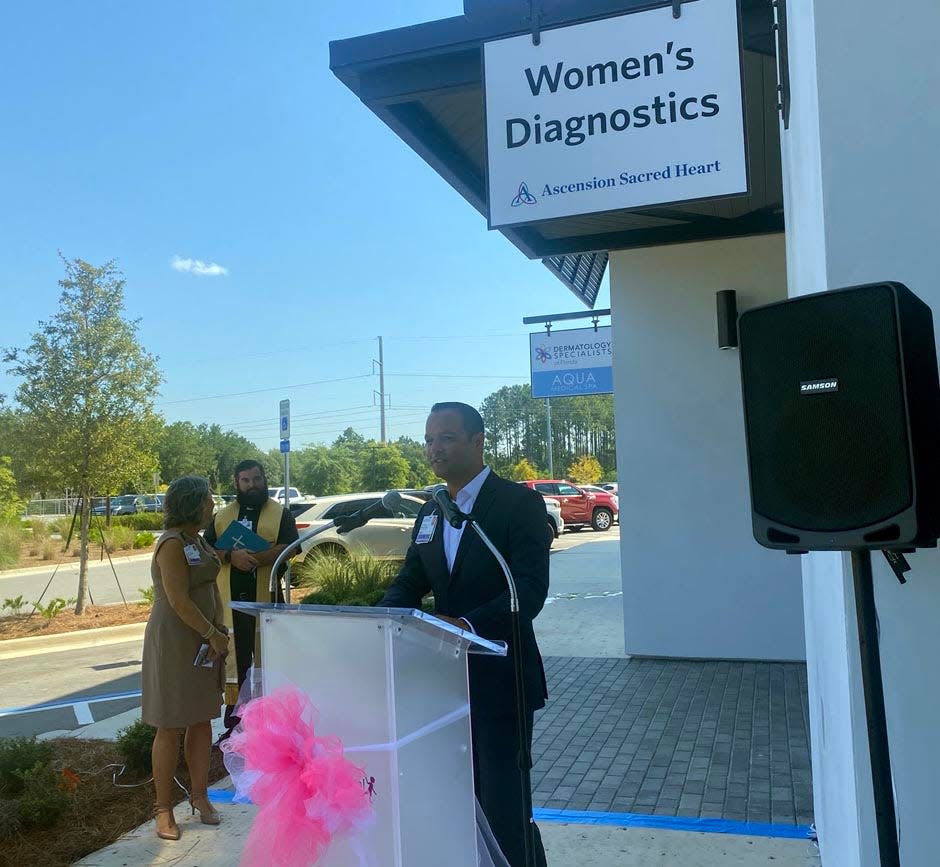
[532,657,813,825]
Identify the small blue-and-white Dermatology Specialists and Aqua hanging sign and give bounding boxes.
[529,325,614,397]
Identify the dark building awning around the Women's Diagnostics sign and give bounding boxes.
[330,0,783,307]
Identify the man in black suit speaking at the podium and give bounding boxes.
[379,403,548,867]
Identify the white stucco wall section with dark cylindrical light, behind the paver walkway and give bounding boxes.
[610,235,804,659]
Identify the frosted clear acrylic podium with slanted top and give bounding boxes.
[231,602,506,867]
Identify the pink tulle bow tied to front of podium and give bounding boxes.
[222,687,372,867]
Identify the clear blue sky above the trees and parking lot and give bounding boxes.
[0,0,609,449]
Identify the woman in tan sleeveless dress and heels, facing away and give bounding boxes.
[141,476,229,840]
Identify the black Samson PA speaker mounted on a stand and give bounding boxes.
[738,283,940,551]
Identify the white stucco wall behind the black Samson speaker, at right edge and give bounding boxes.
[781,0,940,867]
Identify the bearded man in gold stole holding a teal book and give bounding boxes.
[204,460,297,741]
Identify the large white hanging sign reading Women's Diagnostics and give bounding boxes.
[484,0,747,227]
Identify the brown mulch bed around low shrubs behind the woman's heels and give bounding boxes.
[0,738,228,867]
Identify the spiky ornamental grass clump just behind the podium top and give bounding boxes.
[296,549,398,605]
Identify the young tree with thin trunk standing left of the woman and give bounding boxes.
[4,258,162,614]
